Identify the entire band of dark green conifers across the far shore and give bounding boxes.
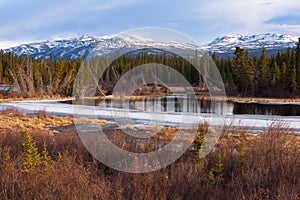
[0,39,300,97]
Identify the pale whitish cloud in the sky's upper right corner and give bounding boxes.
[192,0,300,33]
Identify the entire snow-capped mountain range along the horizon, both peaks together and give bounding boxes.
[4,33,298,59]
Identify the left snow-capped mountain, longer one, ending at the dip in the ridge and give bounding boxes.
[4,36,197,59]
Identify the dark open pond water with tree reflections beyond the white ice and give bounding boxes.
[71,95,300,116]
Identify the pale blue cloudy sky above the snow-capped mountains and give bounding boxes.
[0,0,300,49]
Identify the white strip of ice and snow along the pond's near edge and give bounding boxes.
[0,100,300,133]
